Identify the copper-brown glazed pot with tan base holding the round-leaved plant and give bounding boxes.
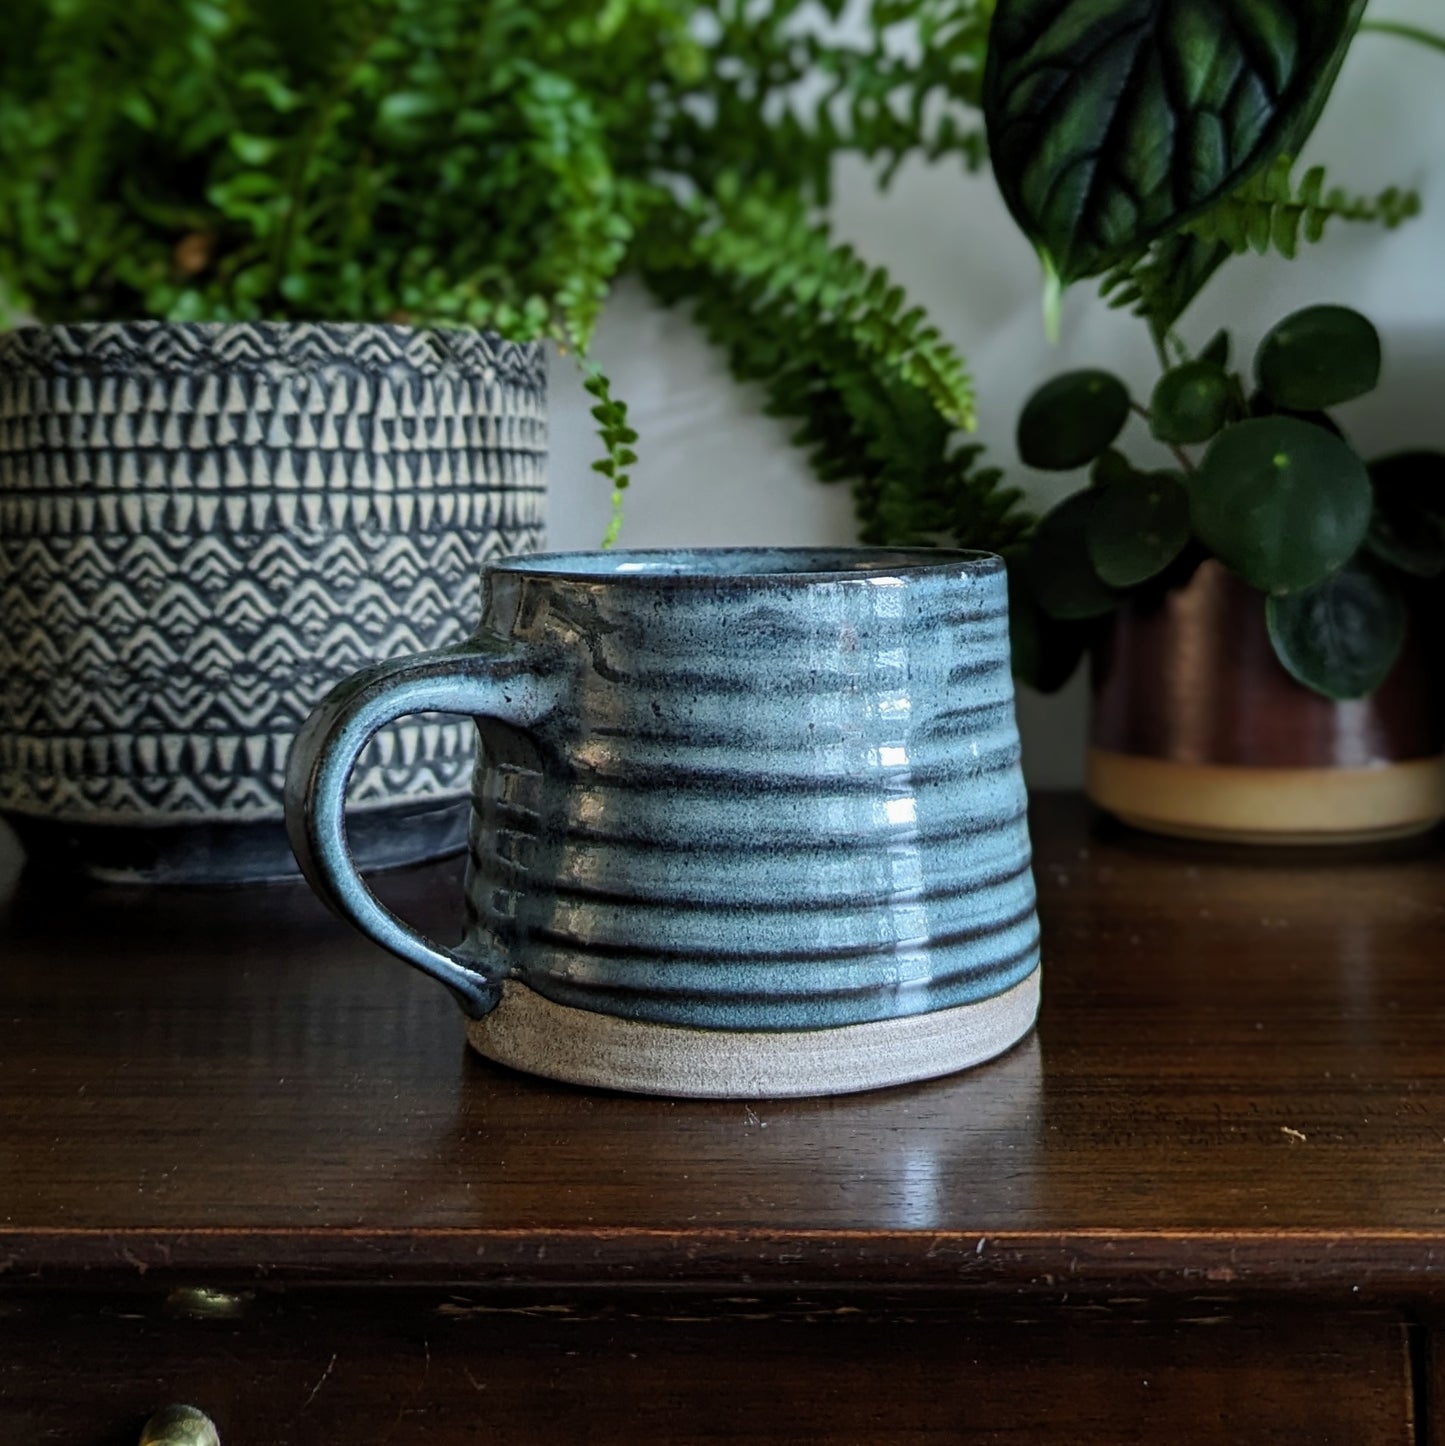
[1088,561,1445,843]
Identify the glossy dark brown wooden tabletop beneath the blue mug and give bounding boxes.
[0,797,1445,1299]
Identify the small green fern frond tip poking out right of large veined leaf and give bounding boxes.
[1185,156,1420,259]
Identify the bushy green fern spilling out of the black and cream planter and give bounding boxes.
[0,0,1026,547]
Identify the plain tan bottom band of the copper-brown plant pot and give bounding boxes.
[1088,748,1445,844]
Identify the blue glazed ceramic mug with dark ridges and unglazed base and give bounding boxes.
[286,548,1039,1098]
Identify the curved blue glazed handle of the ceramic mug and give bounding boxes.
[286,635,557,1019]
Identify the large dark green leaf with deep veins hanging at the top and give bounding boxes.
[984,0,1364,282]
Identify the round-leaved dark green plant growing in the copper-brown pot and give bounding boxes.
[1013,307,1445,698]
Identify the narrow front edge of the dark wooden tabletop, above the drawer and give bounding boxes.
[8,1226,1445,1303]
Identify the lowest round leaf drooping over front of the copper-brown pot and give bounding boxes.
[1266,567,1409,698]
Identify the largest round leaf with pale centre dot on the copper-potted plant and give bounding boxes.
[1189,416,1374,593]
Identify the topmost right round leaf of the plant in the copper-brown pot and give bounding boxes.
[1254,307,1380,412]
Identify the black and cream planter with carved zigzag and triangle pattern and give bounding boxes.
[0,322,545,882]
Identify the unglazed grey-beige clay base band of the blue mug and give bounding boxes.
[467,969,1040,1099]
